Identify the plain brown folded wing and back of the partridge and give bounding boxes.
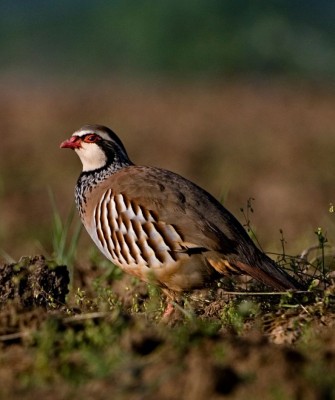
[100,166,247,254]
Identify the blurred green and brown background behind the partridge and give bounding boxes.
[0,0,335,259]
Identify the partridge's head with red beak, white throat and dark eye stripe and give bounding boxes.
[60,125,131,172]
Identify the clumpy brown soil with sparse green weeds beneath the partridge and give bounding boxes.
[0,256,335,400]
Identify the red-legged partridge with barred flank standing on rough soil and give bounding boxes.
[60,125,302,315]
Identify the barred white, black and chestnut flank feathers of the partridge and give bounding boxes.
[88,189,189,270]
